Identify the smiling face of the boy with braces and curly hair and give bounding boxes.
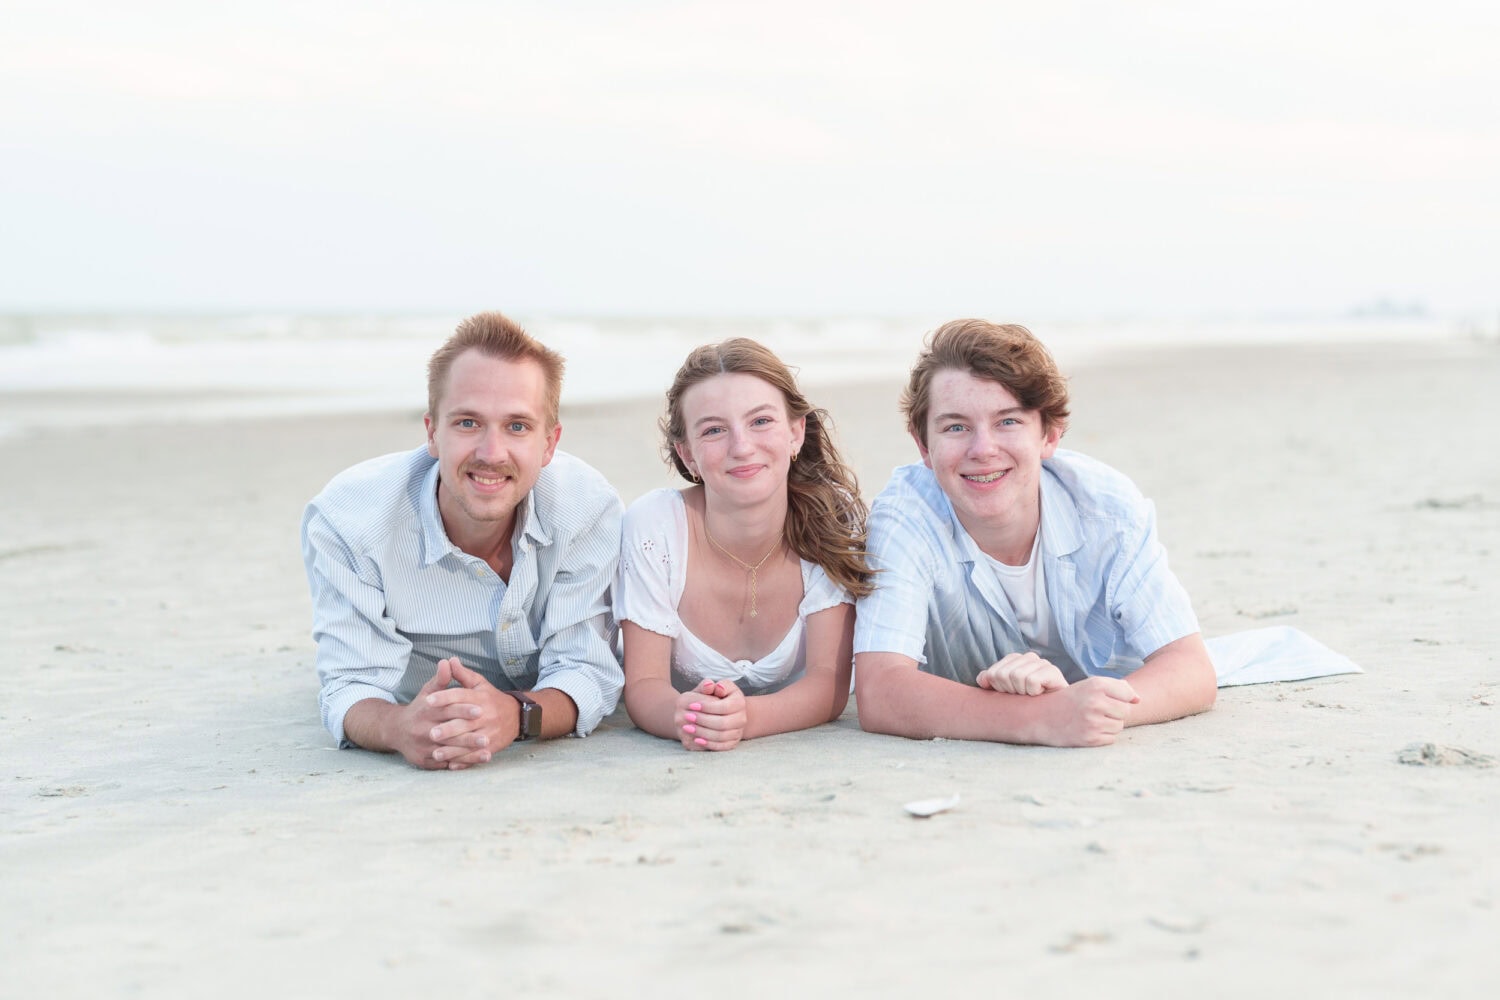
[912,369,1062,559]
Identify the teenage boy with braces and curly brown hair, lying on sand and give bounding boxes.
[855,319,1217,747]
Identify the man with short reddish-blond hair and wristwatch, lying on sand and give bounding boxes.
[302,312,624,771]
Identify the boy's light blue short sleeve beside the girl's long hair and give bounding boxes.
[854,502,935,664]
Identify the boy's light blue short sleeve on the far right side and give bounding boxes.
[1106,499,1199,660]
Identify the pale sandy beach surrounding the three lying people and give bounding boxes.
[0,342,1500,997]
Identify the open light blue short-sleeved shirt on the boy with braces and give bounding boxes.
[854,450,1199,684]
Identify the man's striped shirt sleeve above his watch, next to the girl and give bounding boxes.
[536,487,626,736]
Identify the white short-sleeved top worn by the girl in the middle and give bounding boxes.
[614,489,854,694]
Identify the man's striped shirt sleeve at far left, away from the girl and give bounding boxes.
[302,502,411,747]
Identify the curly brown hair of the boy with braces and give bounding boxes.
[902,319,1068,447]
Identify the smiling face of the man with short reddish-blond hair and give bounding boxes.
[425,351,563,556]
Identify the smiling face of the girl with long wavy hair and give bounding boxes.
[674,372,806,505]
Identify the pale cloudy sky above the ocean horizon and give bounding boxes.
[0,0,1500,318]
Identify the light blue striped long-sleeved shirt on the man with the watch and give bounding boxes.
[302,447,624,745]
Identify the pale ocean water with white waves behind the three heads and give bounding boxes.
[0,313,1473,435]
